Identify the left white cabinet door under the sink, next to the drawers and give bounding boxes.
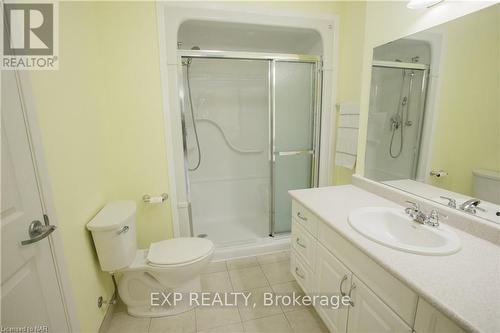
[312,245,352,332]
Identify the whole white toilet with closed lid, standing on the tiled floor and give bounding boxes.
[87,201,214,317]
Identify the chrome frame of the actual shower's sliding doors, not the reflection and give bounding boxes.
[177,50,323,237]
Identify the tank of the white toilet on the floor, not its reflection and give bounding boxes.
[87,200,137,272]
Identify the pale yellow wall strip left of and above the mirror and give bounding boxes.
[356,1,492,174]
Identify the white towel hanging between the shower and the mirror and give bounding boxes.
[335,103,359,169]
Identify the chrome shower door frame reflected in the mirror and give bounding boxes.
[372,60,430,180]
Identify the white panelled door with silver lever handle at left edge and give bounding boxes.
[1,71,69,332]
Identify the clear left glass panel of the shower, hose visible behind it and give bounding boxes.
[183,58,271,246]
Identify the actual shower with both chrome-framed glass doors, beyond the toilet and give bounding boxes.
[178,47,321,248]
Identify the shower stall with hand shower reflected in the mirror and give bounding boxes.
[365,40,430,181]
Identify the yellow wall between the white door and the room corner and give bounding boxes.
[30,3,112,332]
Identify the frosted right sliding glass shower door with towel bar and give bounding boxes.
[271,61,317,234]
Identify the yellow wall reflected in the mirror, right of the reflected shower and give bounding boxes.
[428,6,500,195]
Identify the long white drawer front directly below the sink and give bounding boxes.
[318,222,418,327]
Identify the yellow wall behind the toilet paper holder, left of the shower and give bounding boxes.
[98,2,173,248]
